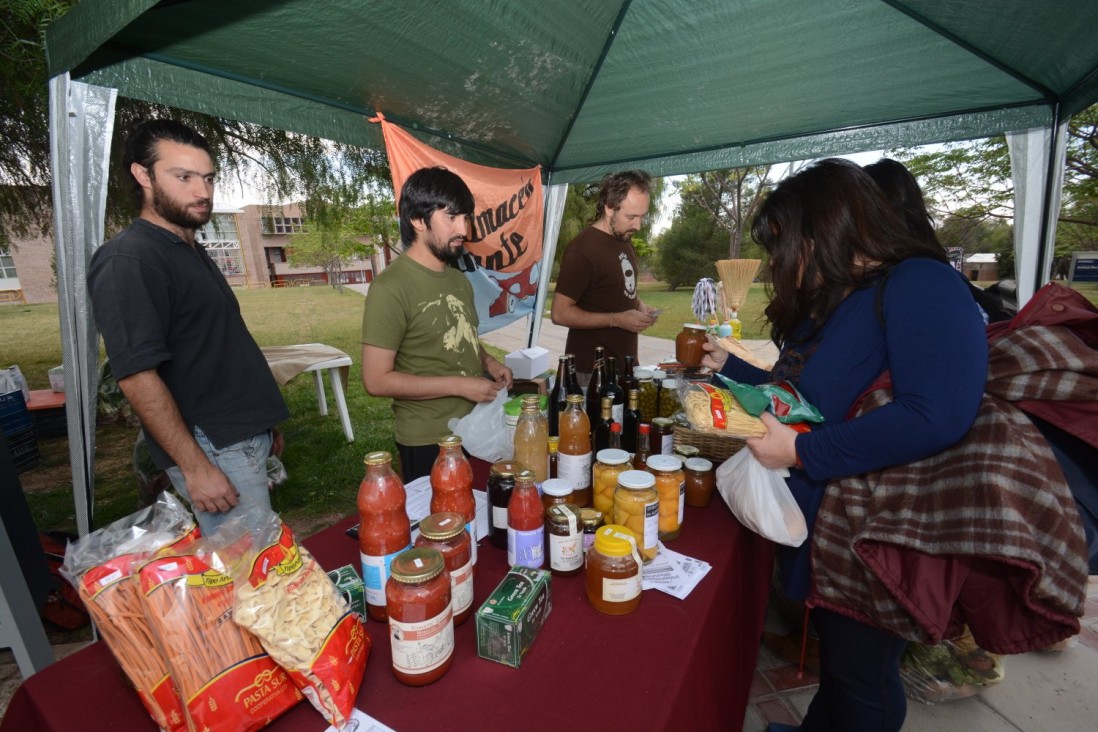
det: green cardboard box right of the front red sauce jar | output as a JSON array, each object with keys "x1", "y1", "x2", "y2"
[{"x1": 477, "y1": 566, "x2": 552, "y2": 668}]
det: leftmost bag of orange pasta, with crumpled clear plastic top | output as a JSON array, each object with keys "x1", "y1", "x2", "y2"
[{"x1": 60, "y1": 493, "x2": 199, "y2": 732}]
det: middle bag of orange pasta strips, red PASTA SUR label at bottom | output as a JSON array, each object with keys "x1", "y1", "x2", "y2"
[{"x1": 139, "y1": 542, "x2": 301, "y2": 732}]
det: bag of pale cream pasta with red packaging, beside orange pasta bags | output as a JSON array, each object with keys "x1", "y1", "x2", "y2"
[{"x1": 225, "y1": 514, "x2": 370, "y2": 729}]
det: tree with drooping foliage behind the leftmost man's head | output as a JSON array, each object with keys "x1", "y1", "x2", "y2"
[{"x1": 0, "y1": 0, "x2": 389, "y2": 245}]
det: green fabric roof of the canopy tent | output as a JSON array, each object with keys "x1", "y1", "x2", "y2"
[{"x1": 46, "y1": 0, "x2": 1098, "y2": 182}]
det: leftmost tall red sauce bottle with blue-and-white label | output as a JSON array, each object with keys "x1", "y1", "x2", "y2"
[{"x1": 358, "y1": 451, "x2": 412, "y2": 621}]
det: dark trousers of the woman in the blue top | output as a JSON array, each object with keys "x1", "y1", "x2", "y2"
[{"x1": 798, "y1": 608, "x2": 907, "y2": 732}]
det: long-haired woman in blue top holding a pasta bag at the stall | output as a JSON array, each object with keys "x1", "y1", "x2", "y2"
[{"x1": 704, "y1": 159, "x2": 987, "y2": 732}]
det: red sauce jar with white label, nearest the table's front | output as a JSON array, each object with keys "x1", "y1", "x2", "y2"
[{"x1": 385, "y1": 547, "x2": 453, "y2": 686}]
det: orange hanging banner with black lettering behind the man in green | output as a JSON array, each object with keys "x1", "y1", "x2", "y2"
[{"x1": 371, "y1": 114, "x2": 545, "y2": 333}]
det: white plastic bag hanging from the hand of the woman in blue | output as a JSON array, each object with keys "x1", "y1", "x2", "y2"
[{"x1": 717, "y1": 448, "x2": 808, "y2": 547}]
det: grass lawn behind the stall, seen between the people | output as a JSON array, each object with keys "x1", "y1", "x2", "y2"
[{"x1": 0, "y1": 277, "x2": 1098, "y2": 536}]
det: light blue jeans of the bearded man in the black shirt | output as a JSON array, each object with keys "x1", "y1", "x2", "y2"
[{"x1": 166, "y1": 427, "x2": 271, "y2": 536}]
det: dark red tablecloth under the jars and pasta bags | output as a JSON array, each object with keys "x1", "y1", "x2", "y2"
[{"x1": 0, "y1": 497, "x2": 772, "y2": 732}]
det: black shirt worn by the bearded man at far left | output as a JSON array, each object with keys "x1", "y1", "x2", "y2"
[{"x1": 88, "y1": 218, "x2": 289, "y2": 468}]
